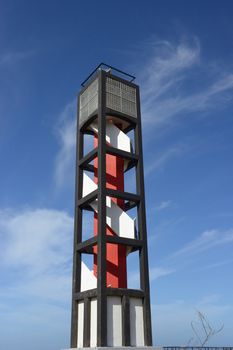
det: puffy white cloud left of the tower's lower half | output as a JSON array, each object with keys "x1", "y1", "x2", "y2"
[{"x1": 0, "y1": 209, "x2": 73, "y2": 273}]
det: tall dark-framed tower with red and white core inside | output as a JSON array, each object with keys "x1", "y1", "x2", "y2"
[{"x1": 71, "y1": 64, "x2": 152, "y2": 348}]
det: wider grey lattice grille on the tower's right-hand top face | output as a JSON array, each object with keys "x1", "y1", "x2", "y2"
[{"x1": 106, "y1": 77, "x2": 137, "y2": 118}]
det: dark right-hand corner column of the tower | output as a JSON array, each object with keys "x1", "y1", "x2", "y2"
[{"x1": 135, "y1": 87, "x2": 152, "y2": 346}]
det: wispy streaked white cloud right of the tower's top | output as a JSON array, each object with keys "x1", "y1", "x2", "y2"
[{"x1": 140, "y1": 38, "x2": 233, "y2": 125}]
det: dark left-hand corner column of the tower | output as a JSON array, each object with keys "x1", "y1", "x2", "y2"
[{"x1": 71, "y1": 95, "x2": 84, "y2": 348}]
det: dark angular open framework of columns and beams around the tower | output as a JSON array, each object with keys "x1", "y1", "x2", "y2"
[{"x1": 71, "y1": 70, "x2": 152, "y2": 348}]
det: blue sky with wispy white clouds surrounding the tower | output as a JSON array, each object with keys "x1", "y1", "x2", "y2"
[{"x1": 0, "y1": 0, "x2": 233, "y2": 350}]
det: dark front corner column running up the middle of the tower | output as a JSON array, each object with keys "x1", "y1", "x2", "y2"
[{"x1": 97, "y1": 70, "x2": 107, "y2": 346}]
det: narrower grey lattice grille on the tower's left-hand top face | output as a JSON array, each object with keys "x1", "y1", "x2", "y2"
[{"x1": 79, "y1": 79, "x2": 98, "y2": 124}]
